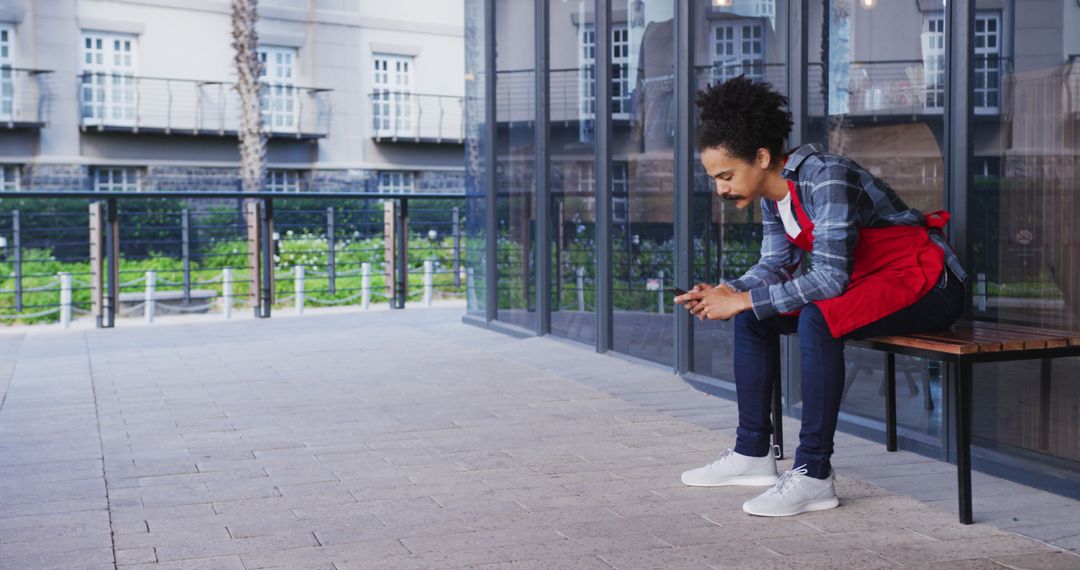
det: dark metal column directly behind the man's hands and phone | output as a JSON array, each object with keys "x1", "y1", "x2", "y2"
[{"x1": 673, "y1": 2, "x2": 695, "y2": 374}]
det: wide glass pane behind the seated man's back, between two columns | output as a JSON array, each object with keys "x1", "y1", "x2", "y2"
[{"x1": 807, "y1": 0, "x2": 947, "y2": 446}]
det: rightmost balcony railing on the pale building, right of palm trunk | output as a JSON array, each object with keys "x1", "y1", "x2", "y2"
[{"x1": 367, "y1": 91, "x2": 465, "y2": 145}]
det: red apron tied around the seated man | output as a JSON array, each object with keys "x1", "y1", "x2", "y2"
[{"x1": 785, "y1": 180, "x2": 949, "y2": 338}]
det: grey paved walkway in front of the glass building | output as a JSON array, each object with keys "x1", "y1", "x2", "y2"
[{"x1": 0, "y1": 310, "x2": 1080, "y2": 570}]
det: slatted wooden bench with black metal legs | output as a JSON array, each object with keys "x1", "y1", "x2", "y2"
[{"x1": 772, "y1": 322, "x2": 1080, "y2": 525}]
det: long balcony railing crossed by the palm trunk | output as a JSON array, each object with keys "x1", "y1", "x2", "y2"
[{"x1": 78, "y1": 72, "x2": 330, "y2": 139}]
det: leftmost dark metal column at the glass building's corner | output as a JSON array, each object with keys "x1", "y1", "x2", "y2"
[{"x1": 484, "y1": 0, "x2": 499, "y2": 322}]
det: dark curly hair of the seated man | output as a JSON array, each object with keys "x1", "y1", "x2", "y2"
[{"x1": 698, "y1": 76, "x2": 792, "y2": 162}]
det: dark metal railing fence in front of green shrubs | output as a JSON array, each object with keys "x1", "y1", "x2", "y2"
[{"x1": 0, "y1": 195, "x2": 471, "y2": 326}]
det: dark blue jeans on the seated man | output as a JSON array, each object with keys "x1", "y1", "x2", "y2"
[{"x1": 734, "y1": 269, "x2": 963, "y2": 478}]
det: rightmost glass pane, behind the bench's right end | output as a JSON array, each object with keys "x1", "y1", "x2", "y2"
[{"x1": 969, "y1": 0, "x2": 1080, "y2": 464}]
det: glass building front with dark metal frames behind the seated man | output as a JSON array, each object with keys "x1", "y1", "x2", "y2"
[{"x1": 464, "y1": 0, "x2": 1080, "y2": 496}]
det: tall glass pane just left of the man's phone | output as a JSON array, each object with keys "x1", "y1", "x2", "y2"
[{"x1": 608, "y1": 0, "x2": 675, "y2": 365}]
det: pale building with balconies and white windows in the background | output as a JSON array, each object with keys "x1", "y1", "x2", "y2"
[{"x1": 0, "y1": 0, "x2": 464, "y2": 193}]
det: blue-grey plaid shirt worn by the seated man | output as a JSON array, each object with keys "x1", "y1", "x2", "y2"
[{"x1": 728, "y1": 145, "x2": 967, "y2": 318}]
